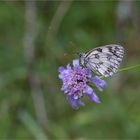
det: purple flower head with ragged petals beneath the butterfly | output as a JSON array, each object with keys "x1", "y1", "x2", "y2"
[{"x1": 58, "y1": 60, "x2": 106, "y2": 109}]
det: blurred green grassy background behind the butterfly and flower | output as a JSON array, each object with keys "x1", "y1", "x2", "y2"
[{"x1": 0, "y1": 0, "x2": 140, "y2": 140}]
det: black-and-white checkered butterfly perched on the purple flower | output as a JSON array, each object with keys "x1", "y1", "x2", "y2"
[{"x1": 79, "y1": 44, "x2": 124, "y2": 77}]
